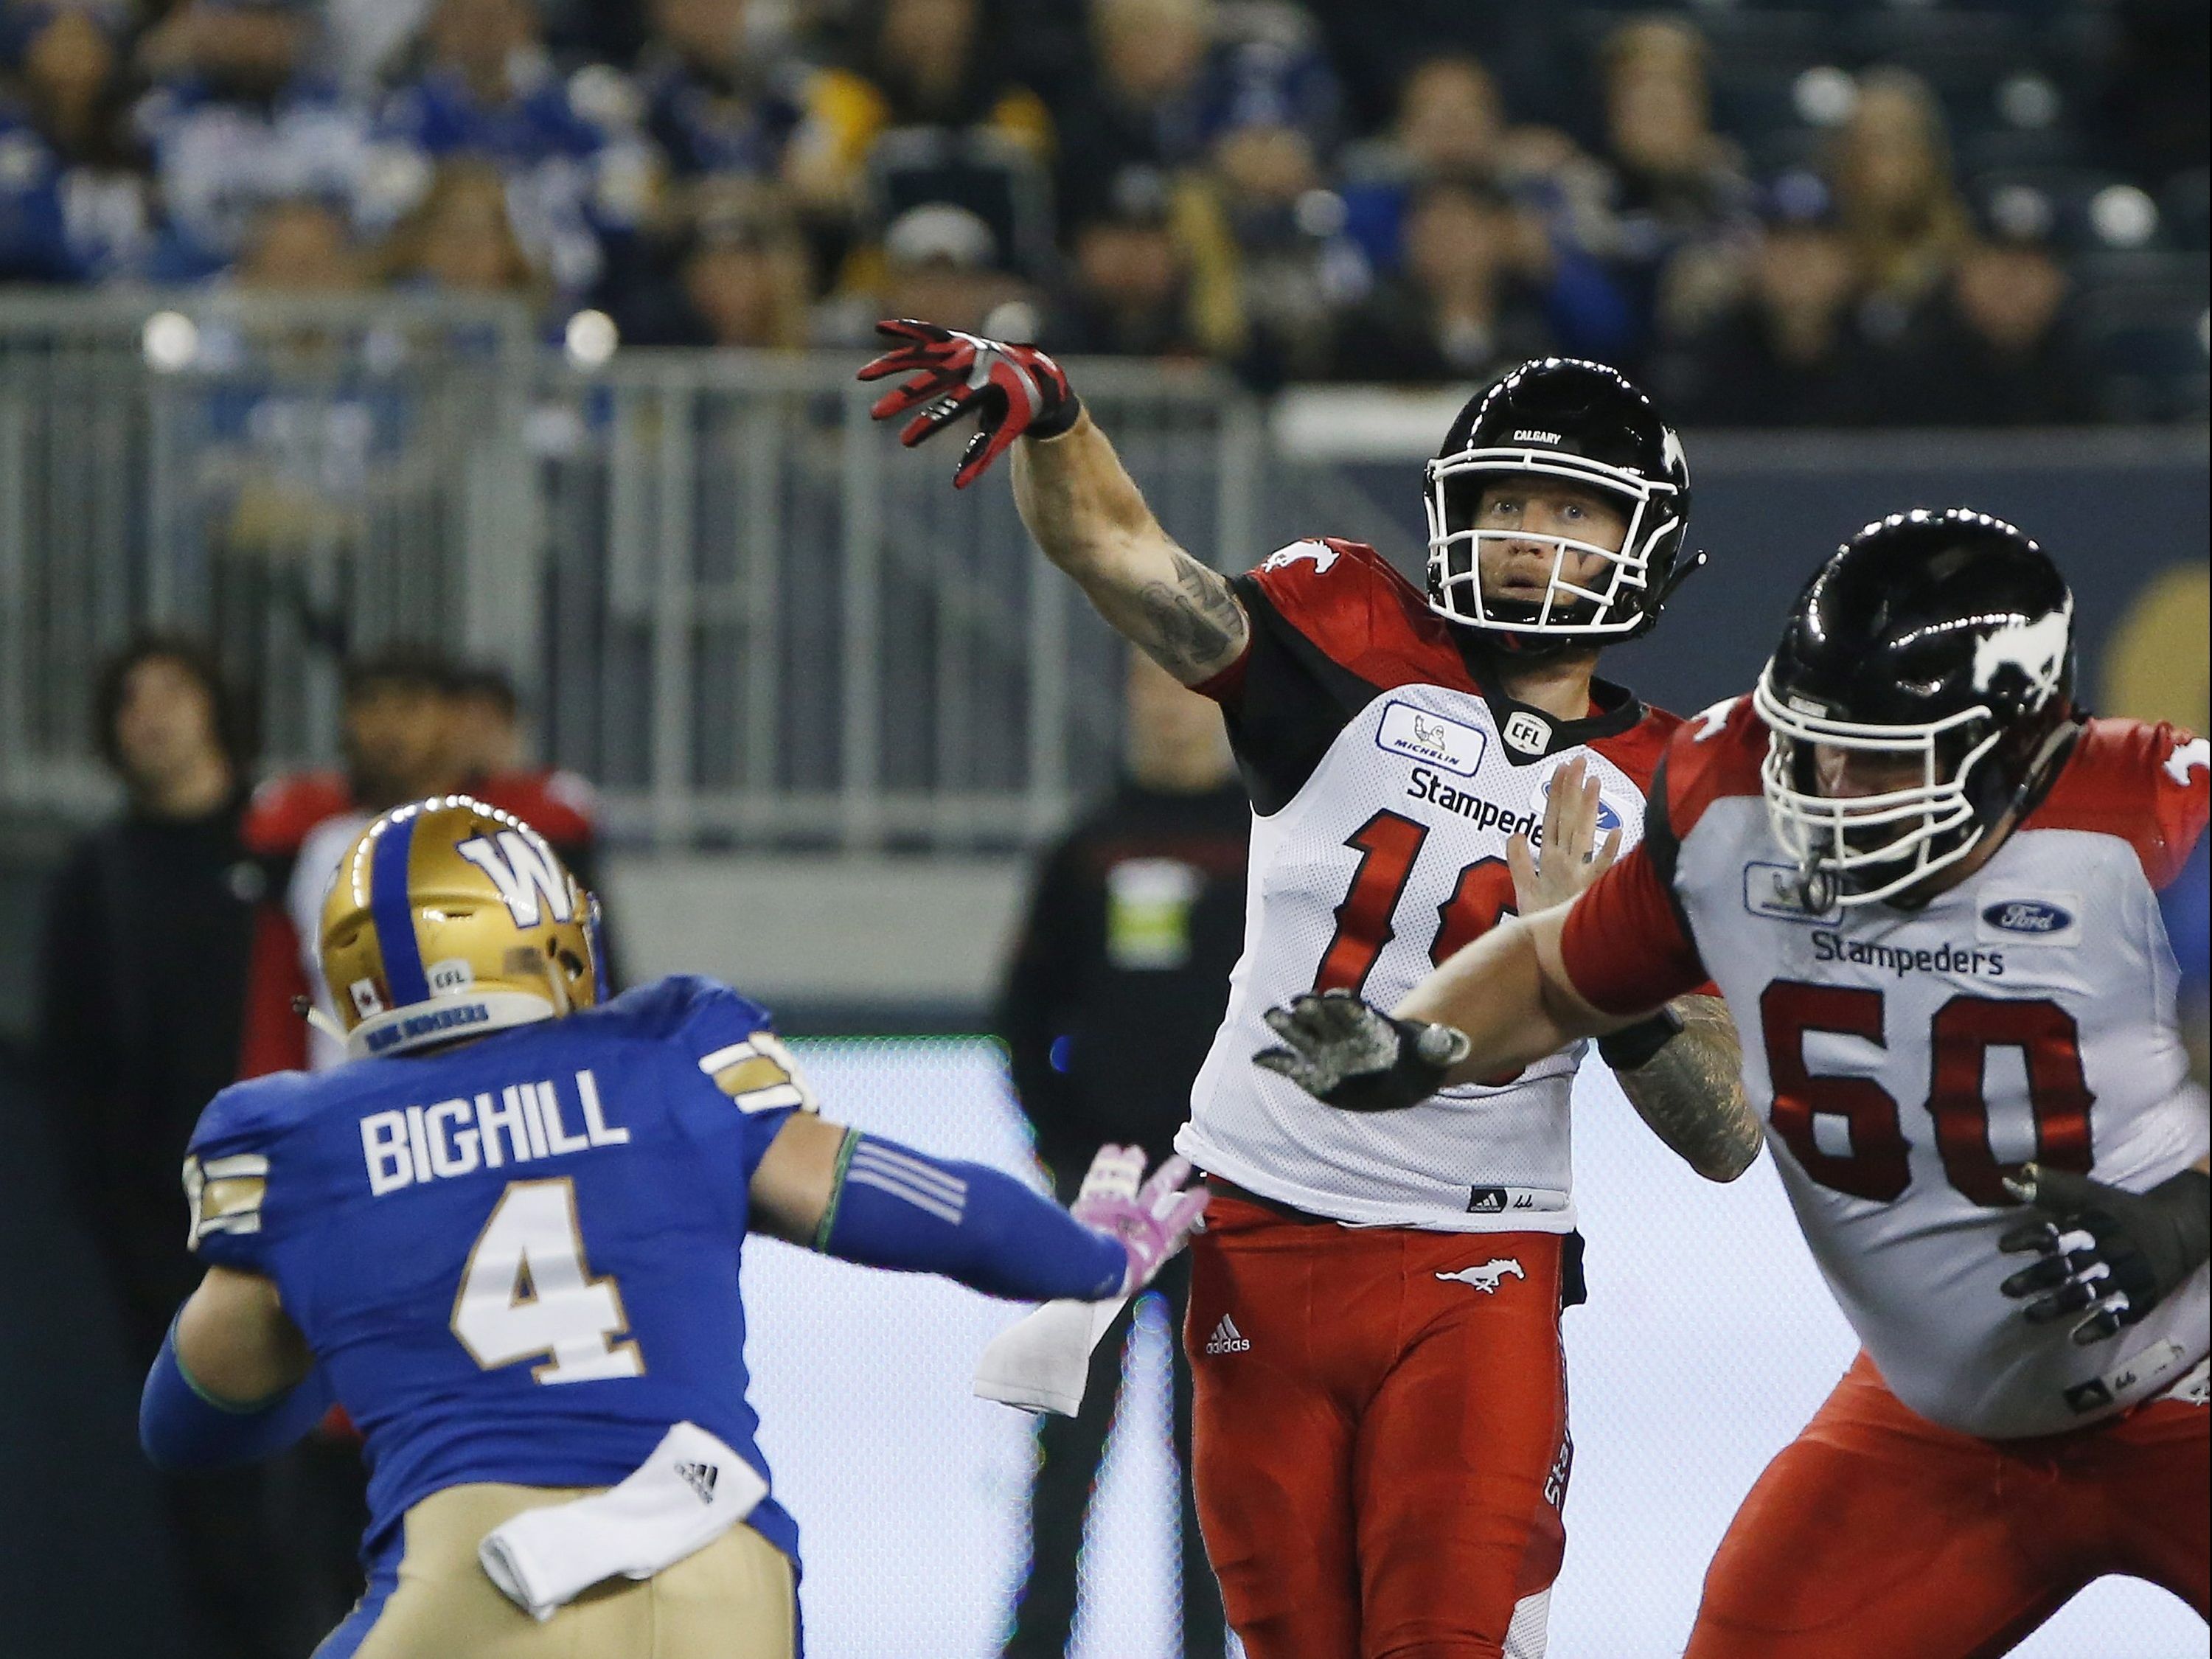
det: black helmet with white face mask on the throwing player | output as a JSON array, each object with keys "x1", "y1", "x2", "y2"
[{"x1": 1427, "y1": 356, "x2": 1703, "y2": 653}]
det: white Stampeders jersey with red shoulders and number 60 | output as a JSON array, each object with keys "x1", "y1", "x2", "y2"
[{"x1": 1568, "y1": 699, "x2": 2212, "y2": 1438}]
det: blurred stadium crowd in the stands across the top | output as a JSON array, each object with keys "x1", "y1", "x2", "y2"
[{"x1": 0, "y1": 0, "x2": 2205, "y2": 427}]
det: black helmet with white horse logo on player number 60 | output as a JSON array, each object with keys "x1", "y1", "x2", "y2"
[{"x1": 1752, "y1": 507, "x2": 2077, "y2": 909}]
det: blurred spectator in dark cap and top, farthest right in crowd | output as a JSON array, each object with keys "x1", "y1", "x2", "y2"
[{"x1": 1882, "y1": 186, "x2": 2093, "y2": 427}]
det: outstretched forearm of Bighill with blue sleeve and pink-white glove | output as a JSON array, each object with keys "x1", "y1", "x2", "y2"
[{"x1": 750, "y1": 1113, "x2": 1206, "y2": 1303}]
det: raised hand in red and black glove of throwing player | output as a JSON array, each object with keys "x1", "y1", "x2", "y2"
[{"x1": 860, "y1": 319, "x2": 1084, "y2": 489}]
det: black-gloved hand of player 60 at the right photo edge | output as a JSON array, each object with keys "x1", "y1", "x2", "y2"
[{"x1": 1997, "y1": 1164, "x2": 2212, "y2": 1347}]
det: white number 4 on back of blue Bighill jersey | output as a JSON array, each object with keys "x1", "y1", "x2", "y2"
[{"x1": 453, "y1": 1177, "x2": 646, "y2": 1382}]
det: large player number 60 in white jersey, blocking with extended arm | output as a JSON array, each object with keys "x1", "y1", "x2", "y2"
[{"x1": 1267, "y1": 509, "x2": 2212, "y2": 1659}]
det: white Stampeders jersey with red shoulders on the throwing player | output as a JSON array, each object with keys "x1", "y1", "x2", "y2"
[{"x1": 1177, "y1": 542, "x2": 1677, "y2": 1232}]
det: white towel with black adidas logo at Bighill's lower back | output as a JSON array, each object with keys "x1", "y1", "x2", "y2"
[{"x1": 476, "y1": 1422, "x2": 768, "y2": 1621}]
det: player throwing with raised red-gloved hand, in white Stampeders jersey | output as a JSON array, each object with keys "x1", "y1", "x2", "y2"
[{"x1": 863, "y1": 323, "x2": 1759, "y2": 1659}]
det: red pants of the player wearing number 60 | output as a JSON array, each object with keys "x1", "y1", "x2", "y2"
[{"x1": 1686, "y1": 1354, "x2": 2212, "y2": 1659}]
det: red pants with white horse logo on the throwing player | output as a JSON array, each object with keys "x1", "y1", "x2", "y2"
[{"x1": 1183, "y1": 1192, "x2": 1573, "y2": 1659}]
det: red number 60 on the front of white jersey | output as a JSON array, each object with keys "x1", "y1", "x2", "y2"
[{"x1": 1759, "y1": 980, "x2": 2095, "y2": 1208}]
